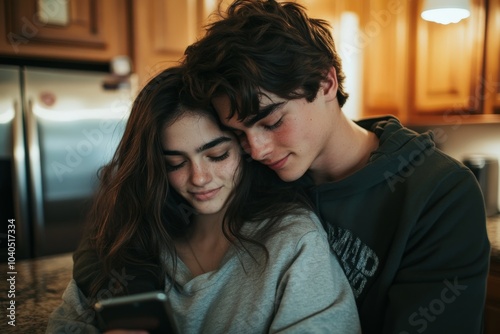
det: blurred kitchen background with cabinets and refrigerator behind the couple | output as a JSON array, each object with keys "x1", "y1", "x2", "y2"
[{"x1": 0, "y1": 0, "x2": 500, "y2": 333}]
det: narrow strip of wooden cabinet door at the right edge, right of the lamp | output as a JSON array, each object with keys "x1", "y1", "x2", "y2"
[{"x1": 483, "y1": 0, "x2": 500, "y2": 117}]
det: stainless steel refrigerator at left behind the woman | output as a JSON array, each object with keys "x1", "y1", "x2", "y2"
[{"x1": 0, "y1": 66, "x2": 132, "y2": 261}]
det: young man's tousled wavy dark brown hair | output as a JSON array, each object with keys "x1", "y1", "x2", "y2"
[{"x1": 184, "y1": 0, "x2": 348, "y2": 120}]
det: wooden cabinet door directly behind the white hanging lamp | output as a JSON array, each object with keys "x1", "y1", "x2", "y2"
[{"x1": 410, "y1": 0, "x2": 485, "y2": 118}]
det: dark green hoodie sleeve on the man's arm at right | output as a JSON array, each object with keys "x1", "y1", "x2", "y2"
[{"x1": 383, "y1": 168, "x2": 490, "y2": 334}]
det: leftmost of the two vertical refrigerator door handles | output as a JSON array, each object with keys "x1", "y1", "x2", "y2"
[{"x1": 12, "y1": 99, "x2": 32, "y2": 258}]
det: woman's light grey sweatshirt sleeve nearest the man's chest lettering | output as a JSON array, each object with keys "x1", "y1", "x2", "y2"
[{"x1": 269, "y1": 215, "x2": 361, "y2": 334}]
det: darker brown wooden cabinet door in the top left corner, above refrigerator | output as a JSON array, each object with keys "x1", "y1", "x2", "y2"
[{"x1": 0, "y1": 0, "x2": 129, "y2": 62}]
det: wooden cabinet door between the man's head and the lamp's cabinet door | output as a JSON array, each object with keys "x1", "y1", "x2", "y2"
[{"x1": 360, "y1": 0, "x2": 410, "y2": 122}]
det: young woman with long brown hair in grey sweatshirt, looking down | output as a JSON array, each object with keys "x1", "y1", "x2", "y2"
[{"x1": 47, "y1": 67, "x2": 360, "y2": 333}]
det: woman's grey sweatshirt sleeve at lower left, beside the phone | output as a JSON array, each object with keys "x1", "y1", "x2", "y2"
[{"x1": 46, "y1": 280, "x2": 100, "y2": 334}]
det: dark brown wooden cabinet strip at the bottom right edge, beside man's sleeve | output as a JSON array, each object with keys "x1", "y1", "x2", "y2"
[{"x1": 484, "y1": 261, "x2": 500, "y2": 334}]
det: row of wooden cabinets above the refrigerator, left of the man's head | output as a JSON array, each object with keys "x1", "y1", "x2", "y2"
[{"x1": 0, "y1": 0, "x2": 225, "y2": 85}]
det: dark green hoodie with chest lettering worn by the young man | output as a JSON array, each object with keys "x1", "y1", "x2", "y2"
[{"x1": 304, "y1": 117, "x2": 490, "y2": 334}]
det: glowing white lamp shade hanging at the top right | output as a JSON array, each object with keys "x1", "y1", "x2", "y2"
[{"x1": 421, "y1": 0, "x2": 470, "y2": 24}]
